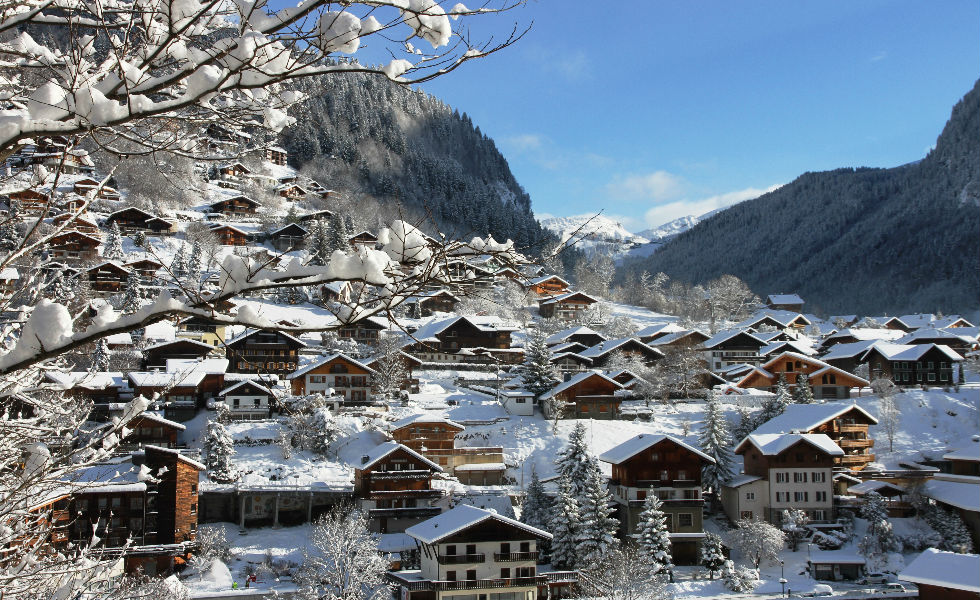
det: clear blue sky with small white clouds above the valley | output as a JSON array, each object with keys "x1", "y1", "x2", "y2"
[{"x1": 422, "y1": 0, "x2": 980, "y2": 231}]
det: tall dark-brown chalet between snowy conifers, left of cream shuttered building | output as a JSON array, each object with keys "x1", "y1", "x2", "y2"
[{"x1": 599, "y1": 434, "x2": 715, "y2": 565}]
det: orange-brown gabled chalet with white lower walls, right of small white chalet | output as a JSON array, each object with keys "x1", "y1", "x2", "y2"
[{"x1": 286, "y1": 354, "x2": 375, "y2": 406}]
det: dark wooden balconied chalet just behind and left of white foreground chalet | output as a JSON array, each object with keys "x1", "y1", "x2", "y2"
[{"x1": 354, "y1": 442, "x2": 442, "y2": 533}]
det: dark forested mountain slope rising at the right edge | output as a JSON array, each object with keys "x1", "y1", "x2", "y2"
[{"x1": 627, "y1": 82, "x2": 980, "y2": 314}]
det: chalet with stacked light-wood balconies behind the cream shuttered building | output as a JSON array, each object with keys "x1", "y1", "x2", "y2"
[{"x1": 752, "y1": 402, "x2": 878, "y2": 471}]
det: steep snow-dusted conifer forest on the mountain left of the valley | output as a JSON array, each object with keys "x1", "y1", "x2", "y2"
[{"x1": 283, "y1": 69, "x2": 557, "y2": 254}]
